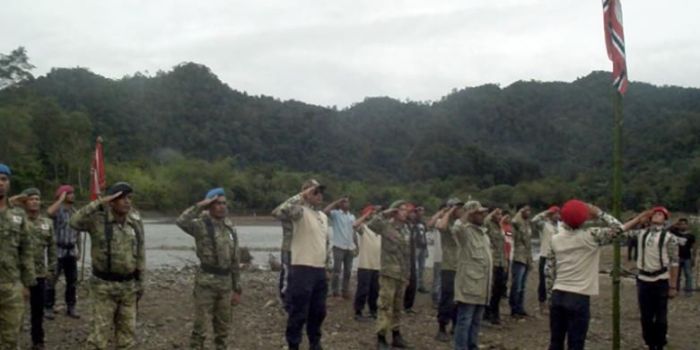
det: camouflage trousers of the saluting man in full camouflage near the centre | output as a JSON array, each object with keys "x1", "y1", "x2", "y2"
[{"x1": 377, "y1": 275, "x2": 406, "y2": 336}]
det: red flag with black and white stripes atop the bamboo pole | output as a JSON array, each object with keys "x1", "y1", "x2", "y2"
[{"x1": 603, "y1": 0, "x2": 629, "y2": 95}]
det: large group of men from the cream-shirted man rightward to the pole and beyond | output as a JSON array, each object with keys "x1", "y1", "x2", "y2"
[{"x1": 273, "y1": 180, "x2": 691, "y2": 350}]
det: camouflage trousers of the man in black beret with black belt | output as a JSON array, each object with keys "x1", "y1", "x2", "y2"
[{"x1": 87, "y1": 277, "x2": 137, "y2": 350}]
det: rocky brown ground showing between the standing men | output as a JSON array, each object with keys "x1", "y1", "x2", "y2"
[{"x1": 23, "y1": 247, "x2": 700, "y2": 350}]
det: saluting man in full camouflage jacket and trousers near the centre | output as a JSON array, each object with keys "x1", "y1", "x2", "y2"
[{"x1": 357, "y1": 200, "x2": 412, "y2": 350}]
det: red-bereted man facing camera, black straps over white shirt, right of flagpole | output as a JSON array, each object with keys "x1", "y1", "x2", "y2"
[{"x1": 627, "y1": 207, "x2": 678, "y2": 350}]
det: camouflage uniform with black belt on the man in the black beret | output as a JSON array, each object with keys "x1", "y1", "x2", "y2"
[{"x1": 70, "y1": 200, "x2": 146, "y2": 349}]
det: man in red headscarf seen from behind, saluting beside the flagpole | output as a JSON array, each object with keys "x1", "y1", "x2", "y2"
[{"x1": 545, "y1": 199, "x2": 639, "y2": 350}]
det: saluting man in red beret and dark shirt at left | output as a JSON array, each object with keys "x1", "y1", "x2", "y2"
[{"x1": 45, "y1": 185, "x2": 80, "y2": 319}]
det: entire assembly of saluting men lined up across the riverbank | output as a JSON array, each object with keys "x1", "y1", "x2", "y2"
[{"x1": 0, "y1": 164, "x2": 691, "y2": 350}]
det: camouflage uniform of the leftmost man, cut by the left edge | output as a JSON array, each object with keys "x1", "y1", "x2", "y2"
[{"x1": 0, "y1": 208, "x2": 36, "y2": 350}]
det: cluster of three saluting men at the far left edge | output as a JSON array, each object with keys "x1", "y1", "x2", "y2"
[{"x1": 0, "y1": 164, "x2": 80, "y2": 349}]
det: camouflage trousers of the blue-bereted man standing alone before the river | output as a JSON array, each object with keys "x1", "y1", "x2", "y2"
[{"x1": 190, "y1": 272, "x2": 232, "y2": 350}]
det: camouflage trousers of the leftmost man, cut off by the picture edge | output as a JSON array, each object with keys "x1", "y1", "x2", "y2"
[{"x1": 0, "y1": 282, "x2": 24, "y2": 350}]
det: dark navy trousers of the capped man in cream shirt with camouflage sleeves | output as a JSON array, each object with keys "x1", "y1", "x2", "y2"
[{"x1": 286, "y1": 265, "x2": 328, "y2": 347}]
